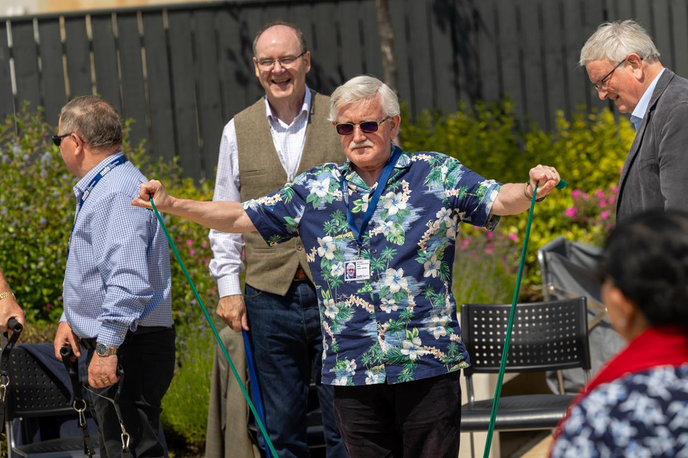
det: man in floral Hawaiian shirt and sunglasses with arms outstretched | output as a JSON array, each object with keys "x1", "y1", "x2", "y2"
[{"x1": 133, "y1": 76, "x2": 559, "y2": 458}]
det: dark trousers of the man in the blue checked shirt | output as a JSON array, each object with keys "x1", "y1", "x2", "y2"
[{"x1": 88, "y1": 328, "x2": 175, "y2": 458}]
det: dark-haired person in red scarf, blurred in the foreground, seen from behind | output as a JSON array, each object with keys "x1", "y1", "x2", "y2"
[{"x1": 551, "y1": 211, "x2": 688, "y2": 458}]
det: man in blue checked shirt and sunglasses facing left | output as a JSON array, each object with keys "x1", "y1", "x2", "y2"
[{"x1": 53, "y1": 96, "x2": 175, "y2": 458}]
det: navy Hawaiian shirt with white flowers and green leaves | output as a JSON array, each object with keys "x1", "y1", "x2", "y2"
[{"x1": 244, "y1": 146, "x2": 501, "y2": 385}]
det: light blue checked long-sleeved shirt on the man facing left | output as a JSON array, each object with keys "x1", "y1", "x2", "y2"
[{"x1": 60, "y1": 153, "x2": 172, "y2": 347}]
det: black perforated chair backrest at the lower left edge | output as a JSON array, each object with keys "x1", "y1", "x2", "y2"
[{"x1": 7, "y1": 346, "x2": 74, "y2": 420}]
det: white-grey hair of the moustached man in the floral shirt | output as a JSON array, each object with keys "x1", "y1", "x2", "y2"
[{"x1": 328, "y1": 75, "x2": 401, "y2": 122}]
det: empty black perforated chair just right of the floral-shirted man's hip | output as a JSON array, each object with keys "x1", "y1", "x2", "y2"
[{"x1": 461, "y1": 297, "x2": 590, "y2": 436}]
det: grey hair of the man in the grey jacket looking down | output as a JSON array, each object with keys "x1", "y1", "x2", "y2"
[{"x1": 579, "y1": 20, "x2": 659, "y2": 67}]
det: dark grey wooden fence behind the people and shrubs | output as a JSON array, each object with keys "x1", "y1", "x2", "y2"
[{"x1": 0, "y1": 0, "x2": 688, "y2": 178}]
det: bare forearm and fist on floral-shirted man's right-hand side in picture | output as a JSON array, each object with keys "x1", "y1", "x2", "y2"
[{"x1": 490, "y1": 165, "x2": 561, "y2": 215}]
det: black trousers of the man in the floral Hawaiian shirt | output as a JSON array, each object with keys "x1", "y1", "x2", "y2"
[{"x1": 334, "y1": 371, "x2": 461, "y2": 458}]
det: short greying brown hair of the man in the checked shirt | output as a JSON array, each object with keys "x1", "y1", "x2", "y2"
[{"x1": 60, "y1": 95, "x2": 122, "y2": 152}]
